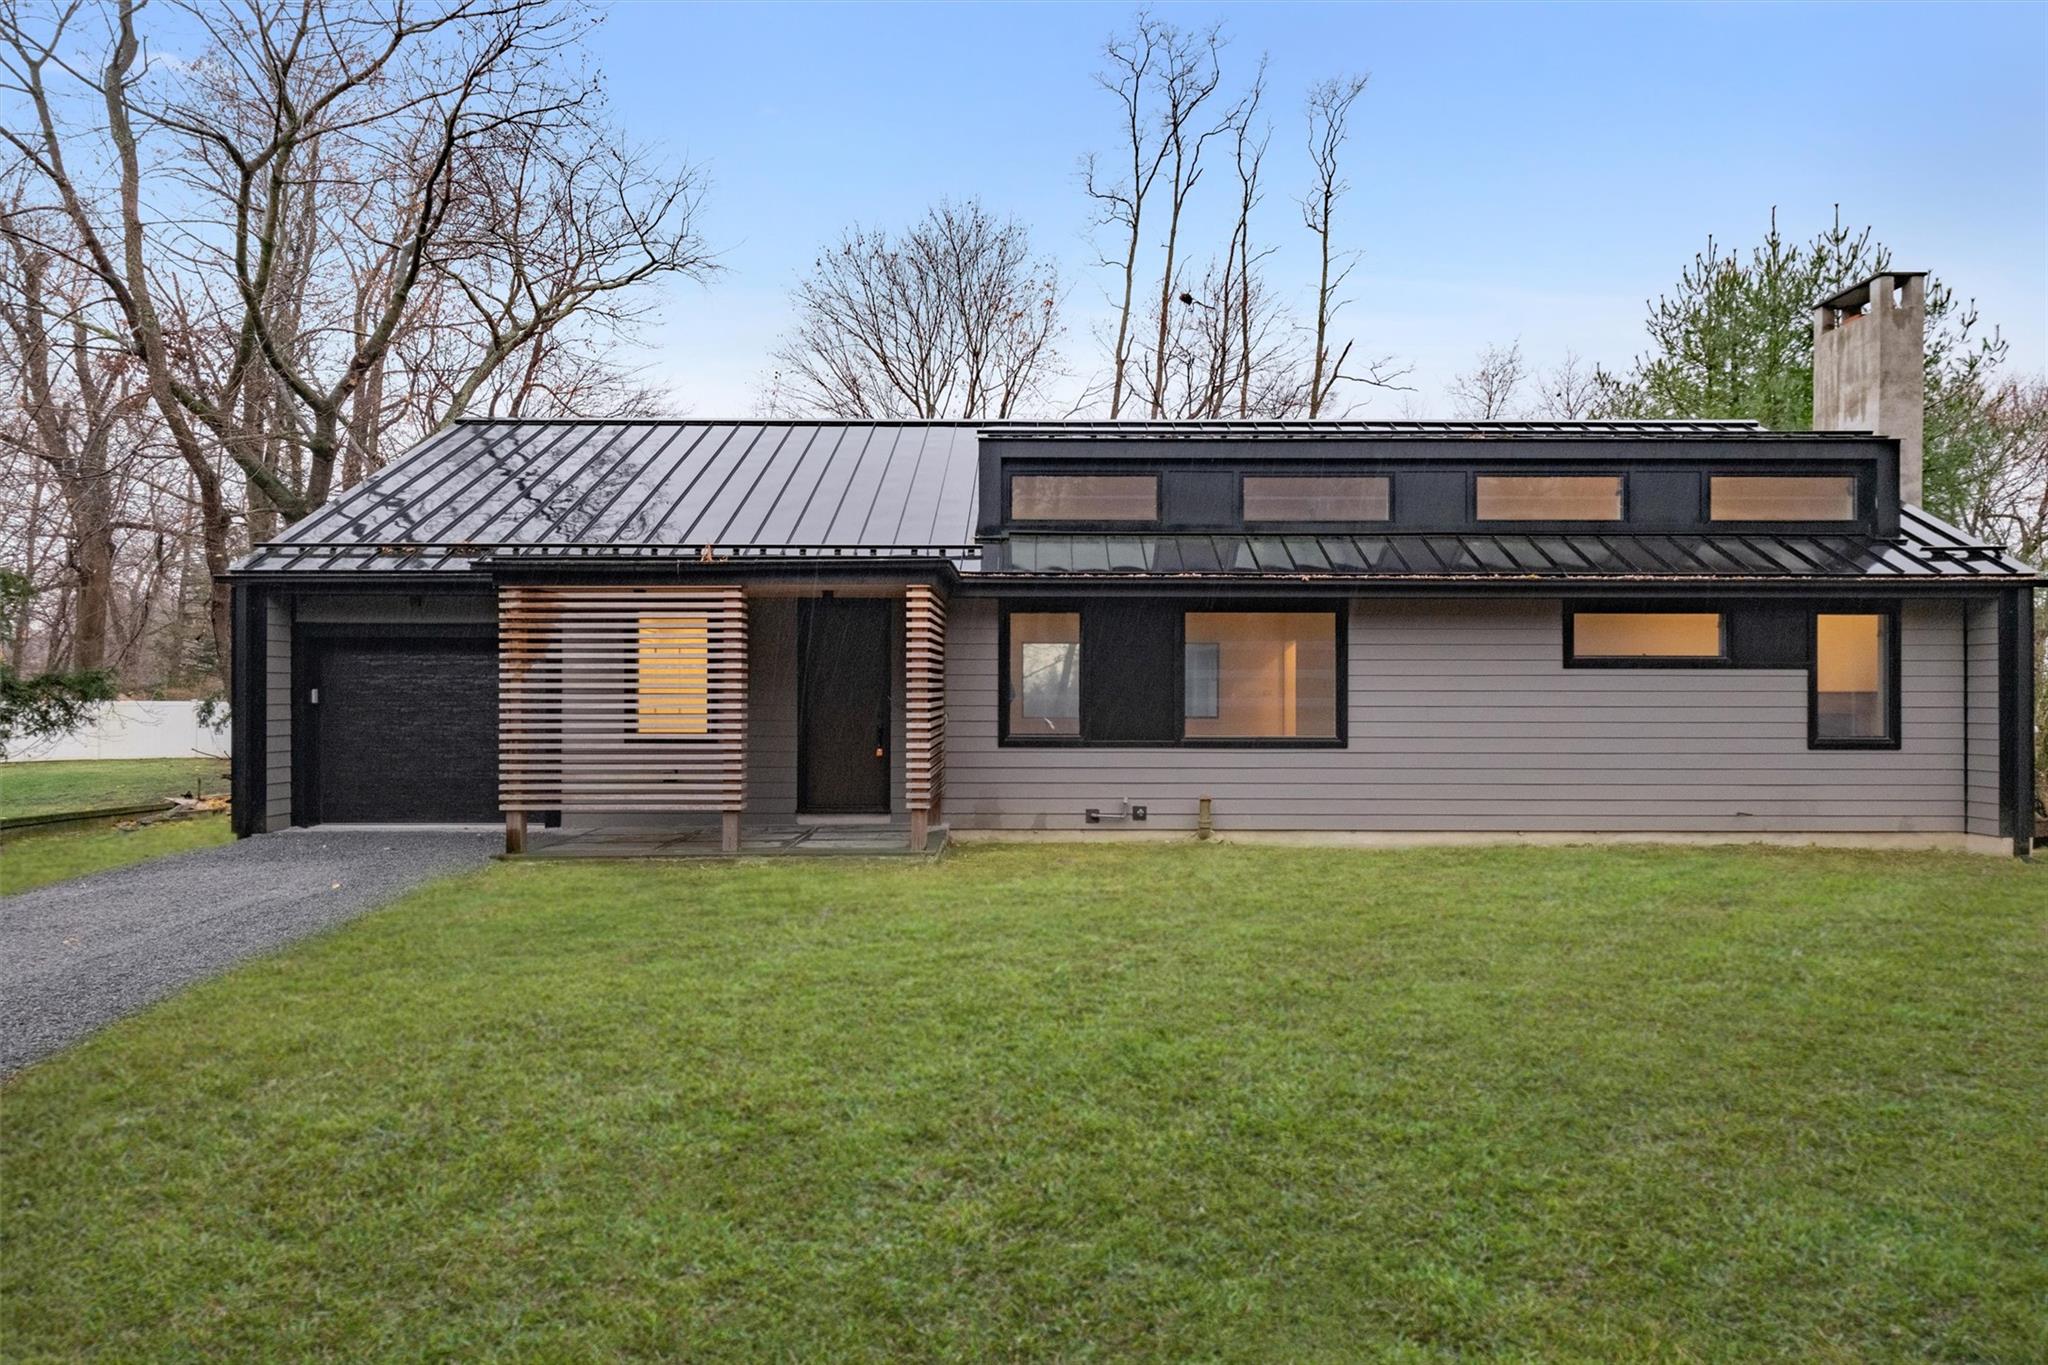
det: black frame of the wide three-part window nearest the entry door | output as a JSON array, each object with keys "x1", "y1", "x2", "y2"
[{"x1": 995, "y1": 598, "x2": 1352, "y2": 749}]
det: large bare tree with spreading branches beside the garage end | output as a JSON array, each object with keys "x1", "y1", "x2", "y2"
[{"x1": 0, "y1": 0, "x2": 709, "y2": 675}]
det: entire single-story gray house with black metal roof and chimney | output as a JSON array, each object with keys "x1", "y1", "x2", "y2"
[{"x1": 233, "y1": 274, "x2": 2044, "y2": 853}]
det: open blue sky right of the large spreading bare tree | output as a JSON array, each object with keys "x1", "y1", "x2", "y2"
[{"x1": 592, "y1": 4, "x2": 2048, "y2": 415}]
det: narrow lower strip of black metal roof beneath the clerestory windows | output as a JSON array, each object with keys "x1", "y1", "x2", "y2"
[{"x1": 981, "y1": 508, "x2": 2036, "y2": 585}]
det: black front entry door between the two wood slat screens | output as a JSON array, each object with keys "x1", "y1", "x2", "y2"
[{"x1": 797, "y1": 598, "x2": 895, "y2": 814}]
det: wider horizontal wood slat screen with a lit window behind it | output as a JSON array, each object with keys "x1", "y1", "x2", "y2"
[{"x1": 498, "y1": 587, "x2": 748, "y2": 810}]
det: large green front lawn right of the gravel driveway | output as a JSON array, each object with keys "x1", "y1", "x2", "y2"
[{"x1": 0, "y1": 845, "x2": 2048, "y2": 1361}]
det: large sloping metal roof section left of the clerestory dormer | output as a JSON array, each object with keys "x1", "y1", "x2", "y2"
[{"x1": 238, "y1": 420, "x2": 981, "y2": 573}]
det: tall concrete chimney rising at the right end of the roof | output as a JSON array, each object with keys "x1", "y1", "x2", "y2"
[{"x1": 1812, "y1": 270, "x2": 1927, "y2": 505}]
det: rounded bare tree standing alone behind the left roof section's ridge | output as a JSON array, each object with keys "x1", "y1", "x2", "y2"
[{"x1": 764, "y1": 201, "x2": 1061, "y2": 417}]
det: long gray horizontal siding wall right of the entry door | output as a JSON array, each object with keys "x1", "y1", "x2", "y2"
[{"x1": 946, "y1": 600, "x2": 1964, "y2": 833}]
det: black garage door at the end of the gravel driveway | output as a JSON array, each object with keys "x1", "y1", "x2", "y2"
[{"x1": 293, "y1": 636, "x2": 498, "y2": 825}]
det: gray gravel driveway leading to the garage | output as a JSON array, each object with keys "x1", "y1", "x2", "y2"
[{"x1": 0, "y1": 829, "x2": 502, "y2": 1074}]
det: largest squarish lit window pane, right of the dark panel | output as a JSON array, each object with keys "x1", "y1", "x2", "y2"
[{"x1": 1182, "y1": 612, "x2": 1337, "y2": 739}]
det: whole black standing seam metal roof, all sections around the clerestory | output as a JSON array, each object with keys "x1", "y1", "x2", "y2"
[{"x1": 236, "y1": 420, "x2": 2032, "y2": 581}]
